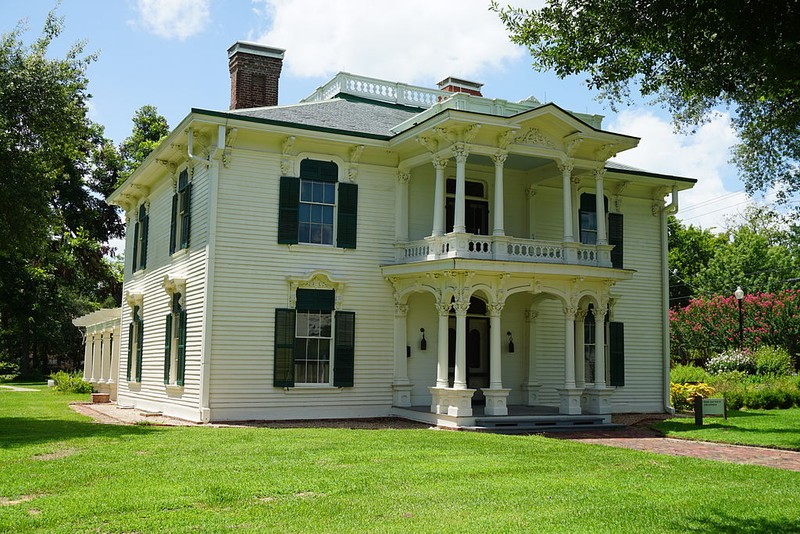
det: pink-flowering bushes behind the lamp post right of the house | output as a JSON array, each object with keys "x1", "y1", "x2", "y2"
[{"x1": 669, "y1": 289, "x2": 800, "y2": 360}]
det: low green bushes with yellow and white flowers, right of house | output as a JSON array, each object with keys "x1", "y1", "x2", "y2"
[{"x1": 670, "y1": 346, "x2": 800, "y2": 410}]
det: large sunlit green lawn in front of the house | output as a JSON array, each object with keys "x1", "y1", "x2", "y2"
[{"x1": 0, "y1": 390, "x2": 800, "y2": 533}]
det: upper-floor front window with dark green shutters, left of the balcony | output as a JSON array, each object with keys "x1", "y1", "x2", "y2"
[{"x1": 278, "y1": 159, "x2": 358, "y2": 248}]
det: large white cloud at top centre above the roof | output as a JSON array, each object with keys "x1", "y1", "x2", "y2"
[{"x1": 255, "y1": 0, "x2": 542, "y2": 84}]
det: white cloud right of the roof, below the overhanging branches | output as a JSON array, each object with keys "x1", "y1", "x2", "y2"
[{"x1": 608, "y1": 109, "x2": 750, "y2": 230}]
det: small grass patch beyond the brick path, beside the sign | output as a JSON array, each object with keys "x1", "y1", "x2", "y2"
[{"x1": 654, "y1": 408, "x2": 800, "y2": 451}]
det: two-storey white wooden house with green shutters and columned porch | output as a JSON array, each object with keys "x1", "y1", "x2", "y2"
[{"x1": 100, "y1": 42, "x2": 695, "y2": 425}]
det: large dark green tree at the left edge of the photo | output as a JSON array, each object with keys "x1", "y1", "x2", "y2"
[{"x1": 0, "y1": 12, "x2": 124, "y2": 382}]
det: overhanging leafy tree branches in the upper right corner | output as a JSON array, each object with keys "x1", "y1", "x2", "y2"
[{"x1": 492, "y1": 0, "x2": 800, "y2": 199}]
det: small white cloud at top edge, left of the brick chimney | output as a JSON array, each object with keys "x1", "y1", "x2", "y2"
[{"x1": 131, "y1": 0, "x2": 211, "y2": 41}]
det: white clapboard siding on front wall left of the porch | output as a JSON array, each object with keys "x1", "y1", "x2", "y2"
[{"x1": 205, "y1": 151, "x2": 396, "y2": 418}]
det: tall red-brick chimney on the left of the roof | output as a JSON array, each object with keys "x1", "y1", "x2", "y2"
[{"x1": 228, "y1": 41, "x2": 285, "y2": 109}]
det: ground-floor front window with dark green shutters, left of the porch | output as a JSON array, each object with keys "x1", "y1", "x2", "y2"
[{"x1": 274, "y1": 289, "x2": 355, "y2": 387}]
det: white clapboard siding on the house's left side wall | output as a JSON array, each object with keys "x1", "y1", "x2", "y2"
[{"x1": 118, "y1": 166, "x2": 209, "y2": 420}]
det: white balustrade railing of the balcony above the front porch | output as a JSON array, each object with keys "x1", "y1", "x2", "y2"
[{"x1": 396, "y1": 234, "x2": 613, "y2": 267}]
